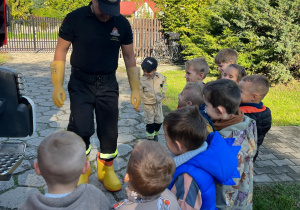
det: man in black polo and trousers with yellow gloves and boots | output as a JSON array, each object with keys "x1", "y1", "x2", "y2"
[{"x1": 50, "y1": 0, "x2": 141, "y2": 191}]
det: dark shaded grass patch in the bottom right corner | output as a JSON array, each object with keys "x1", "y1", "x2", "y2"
[{"x1": 253, "y1": 183, "x2": 300, "y2": 210}]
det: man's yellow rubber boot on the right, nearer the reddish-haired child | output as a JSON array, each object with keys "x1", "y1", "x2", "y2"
[{"x1": 97, "y1": 152, "x2": 122, "y2": 192}]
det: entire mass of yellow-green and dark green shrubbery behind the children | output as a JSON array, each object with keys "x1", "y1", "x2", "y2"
[{"x1": 155, "y1": 0, "x2": 300, "y2": 82}]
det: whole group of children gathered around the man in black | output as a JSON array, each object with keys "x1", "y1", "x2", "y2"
[{"x1": 20, "y1": 49, "x2": 271, "y2": 210}]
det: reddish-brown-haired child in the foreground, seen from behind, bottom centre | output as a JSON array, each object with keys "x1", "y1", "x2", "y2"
[{"x1": 114, "y1": 141, "x2": 180, "y2": 210}]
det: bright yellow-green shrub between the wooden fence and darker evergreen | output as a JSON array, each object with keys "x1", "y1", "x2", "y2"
[{"x1": 155, "y1": 0, "x2": 227, "y2": 73}]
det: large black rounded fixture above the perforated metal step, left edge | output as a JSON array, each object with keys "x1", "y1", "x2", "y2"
[{"x1": 0, "y1": 67, "x2": 35, "y2": 137}]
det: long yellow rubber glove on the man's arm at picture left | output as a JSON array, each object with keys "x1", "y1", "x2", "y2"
[{"x1": 50, "y1": 61, "x2": 66, "y2": 107}]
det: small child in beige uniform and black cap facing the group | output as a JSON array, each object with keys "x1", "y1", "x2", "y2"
[{"x1": 137, "y1": 57, "x2": 168, "y2": 141}]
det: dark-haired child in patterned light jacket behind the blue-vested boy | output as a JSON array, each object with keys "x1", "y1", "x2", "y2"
[{"x1": 203, "y1": 79, "x2": 257, "y2": 209}]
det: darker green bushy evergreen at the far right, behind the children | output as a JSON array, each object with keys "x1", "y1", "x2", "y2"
[{"x1": 213, "y1": 0, "x2": 300, "y2": 82}]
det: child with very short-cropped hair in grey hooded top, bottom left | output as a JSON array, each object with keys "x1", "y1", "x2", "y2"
[{"x1": 19, "y1": 131, "x2": 110, "y2": 210}]
